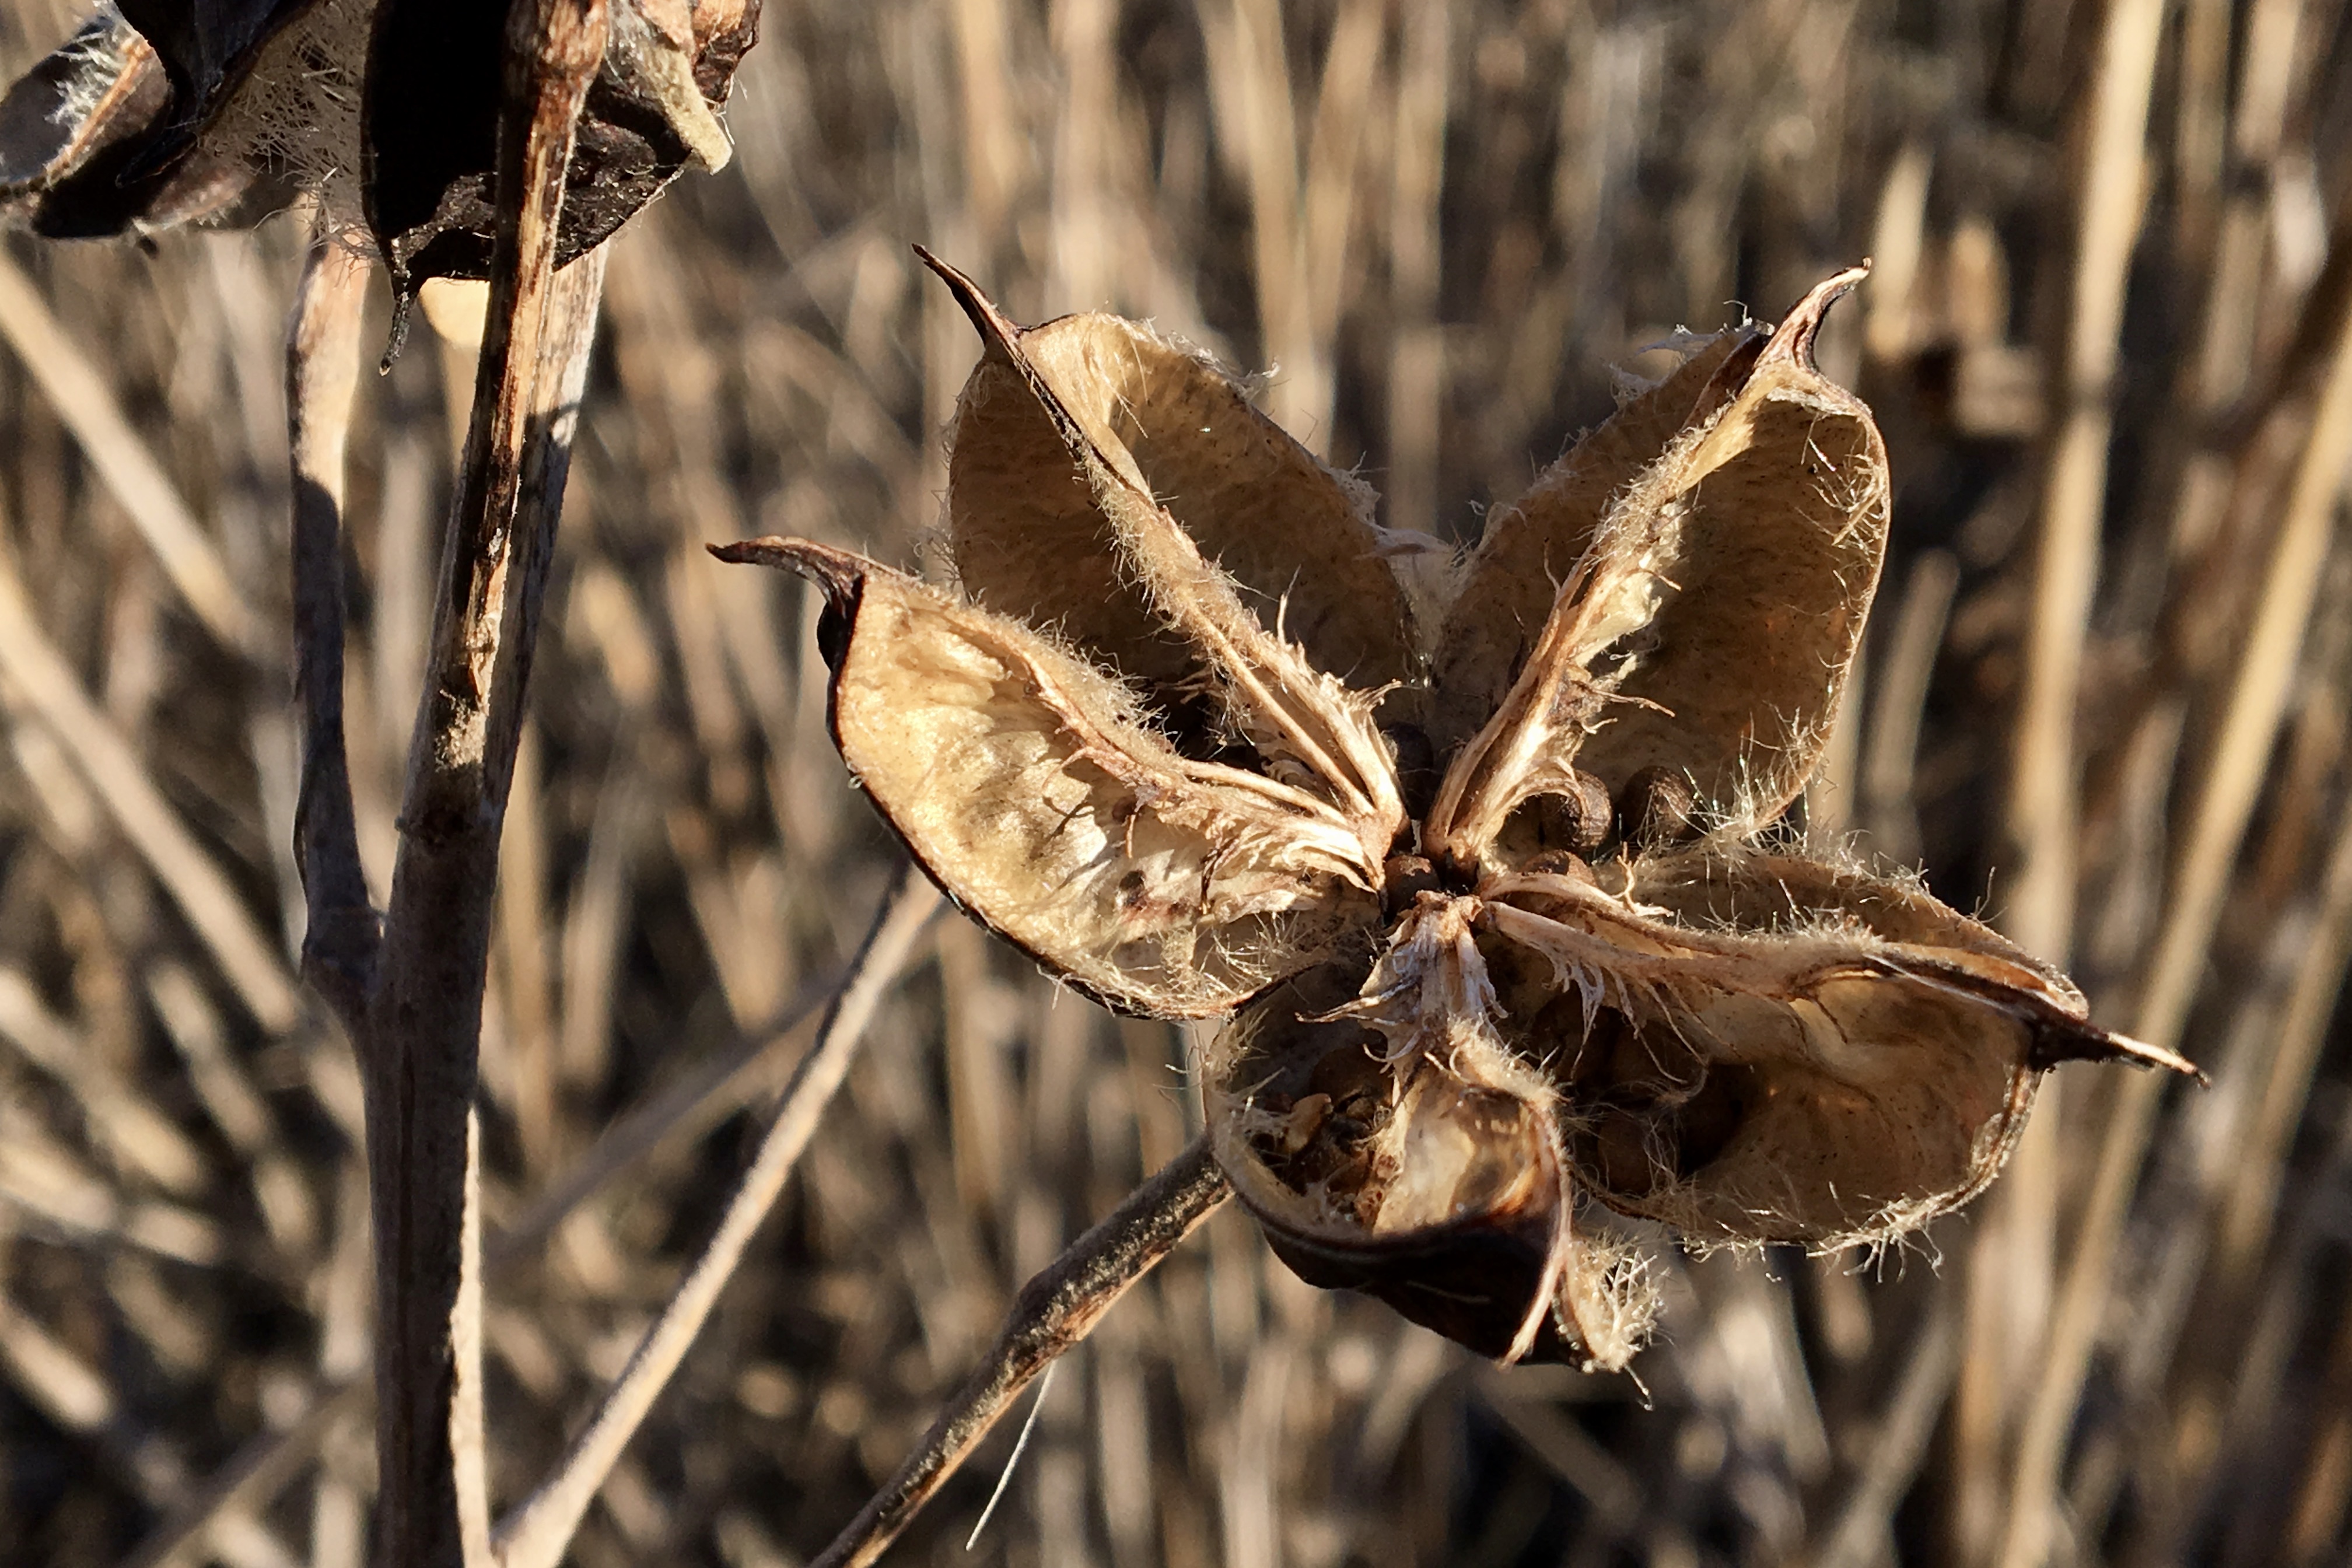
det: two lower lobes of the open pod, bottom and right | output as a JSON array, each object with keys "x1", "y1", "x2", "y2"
[{"x1": 1206, "y1": 851, "x2": 2190, "y2": 1366}]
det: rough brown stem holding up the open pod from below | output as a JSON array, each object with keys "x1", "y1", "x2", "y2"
[{"x1": 814, "y1": 1133, "x2": 1233, "y2": 1568}]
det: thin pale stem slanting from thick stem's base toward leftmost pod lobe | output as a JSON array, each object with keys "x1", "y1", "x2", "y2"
[{"x1": 496, "y1": 865, "x2": 941, "y2": 1568}]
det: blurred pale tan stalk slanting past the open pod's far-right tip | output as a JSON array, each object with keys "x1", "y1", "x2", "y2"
[{"x1": 1999, "y1": 217, "x2": 2352, "y2": 1568}]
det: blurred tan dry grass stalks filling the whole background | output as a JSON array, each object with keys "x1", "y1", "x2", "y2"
[{"x1": 0, "y1": 0, "x2": 2352, "y2": 1568}]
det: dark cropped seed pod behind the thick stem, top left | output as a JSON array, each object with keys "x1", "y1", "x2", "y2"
[{"x1": 0, "y1": 0, "x2": 760, "y2": 292}]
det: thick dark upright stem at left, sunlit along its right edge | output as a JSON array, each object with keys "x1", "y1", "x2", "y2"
[{"x1": 358, "y1": 0, "x2": 607, "y2": 1568}]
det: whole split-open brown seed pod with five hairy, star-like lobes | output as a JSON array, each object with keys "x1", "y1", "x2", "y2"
[{"x1": 715, "y1": 254, "x2": 2194, "y2": 1368}]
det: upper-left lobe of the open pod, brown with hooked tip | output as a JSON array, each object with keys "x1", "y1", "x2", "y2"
[{"x1": 932, "y1": 261, "x2": 1413, "y2": 738}]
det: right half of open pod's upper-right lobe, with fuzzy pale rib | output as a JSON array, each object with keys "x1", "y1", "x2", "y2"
[{"x1": 1425, "y1": 270, "x2": 1889, "y2": 865}]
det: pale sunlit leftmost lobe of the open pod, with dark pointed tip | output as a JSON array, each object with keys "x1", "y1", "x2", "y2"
[{"x1": 720, "y1": 541, "x2": 1381, "y2": 1018}]
